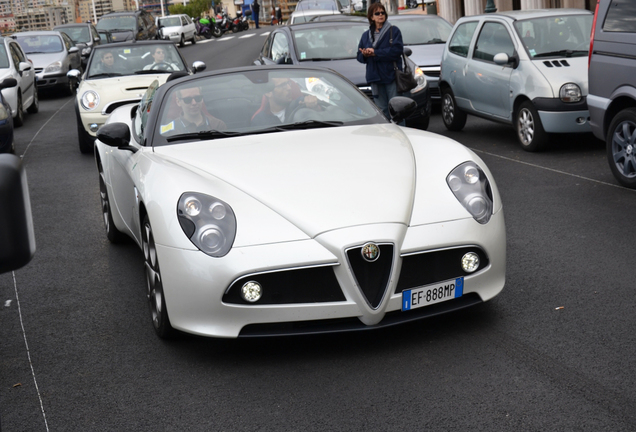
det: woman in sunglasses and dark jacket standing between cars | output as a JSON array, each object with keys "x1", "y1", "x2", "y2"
[{"x1": 358, "y1": 2, "x2": 404, "y2": 118}]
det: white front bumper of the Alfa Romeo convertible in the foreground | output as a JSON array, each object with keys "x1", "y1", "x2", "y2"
[{"x1": 156, "y1": 211, "x2": 506, "y2": 338}]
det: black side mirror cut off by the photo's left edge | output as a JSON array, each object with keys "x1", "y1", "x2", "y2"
[{"x1": 0, "y1": 154, "x2": 35, "y2": 273}]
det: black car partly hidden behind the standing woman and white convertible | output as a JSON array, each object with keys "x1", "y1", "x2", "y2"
[{"x1": 254, "y1": 19, "x2": 431, "y2": 129}]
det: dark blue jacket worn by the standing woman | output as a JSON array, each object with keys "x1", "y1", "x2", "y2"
[{"x1": 358, "y1": 23, "x2": 404, "y2": 84}]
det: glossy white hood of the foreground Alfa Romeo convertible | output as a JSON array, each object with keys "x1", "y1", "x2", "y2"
[{"x1": 154, "y1": 124, "x2": 416, "y2": 237}]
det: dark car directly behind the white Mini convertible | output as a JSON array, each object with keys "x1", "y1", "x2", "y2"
[{"x1": 95, "y1": 10, "x2": 157, "y2": 42}]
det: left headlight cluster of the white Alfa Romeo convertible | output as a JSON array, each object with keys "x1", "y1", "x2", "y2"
[{"x1": 177, "y1": 192, "x2": 236, "y2": 257}]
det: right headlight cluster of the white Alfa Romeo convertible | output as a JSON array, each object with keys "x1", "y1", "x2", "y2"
[{"x1": 446, "y1": 162, "x2": 493, "y2": 224}]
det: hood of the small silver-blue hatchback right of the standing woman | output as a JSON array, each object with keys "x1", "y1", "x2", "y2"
[{"x1": 532, "y1": 56, "x2": 588, "y2": 97}]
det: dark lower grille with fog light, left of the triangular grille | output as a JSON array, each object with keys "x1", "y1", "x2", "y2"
[{"x1": 223, "y1": 266, "x2": 346, "y2": 306}]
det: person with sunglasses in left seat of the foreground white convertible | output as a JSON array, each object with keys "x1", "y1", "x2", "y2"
[{"x1": 161, "y1": 87, "x2": 227, "y2": 135}]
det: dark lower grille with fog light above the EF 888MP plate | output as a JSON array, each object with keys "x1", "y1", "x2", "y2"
[{"x1": 395, "y1": 246, "x2": 489, "y2": 294}]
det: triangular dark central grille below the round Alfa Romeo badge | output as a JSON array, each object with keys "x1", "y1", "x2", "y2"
[{"x1": 347, "y1": 244, "x2": 393, "y2": 309}]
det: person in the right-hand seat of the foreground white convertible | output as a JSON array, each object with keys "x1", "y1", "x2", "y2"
[{"x1": 252, "y1": 78, "x2": 321, "y2": 126}]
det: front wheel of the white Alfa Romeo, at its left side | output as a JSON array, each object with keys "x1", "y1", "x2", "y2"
[{"x1": 141, "y1": 216, "x2": 175, "y2": 339}]
